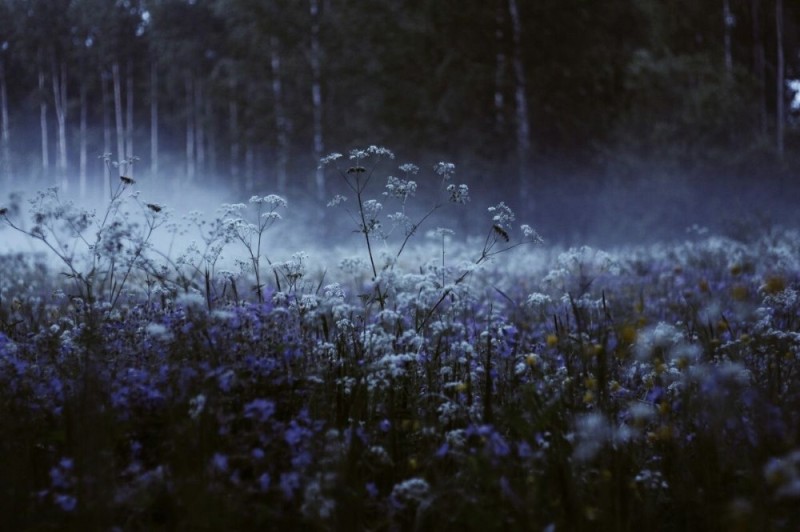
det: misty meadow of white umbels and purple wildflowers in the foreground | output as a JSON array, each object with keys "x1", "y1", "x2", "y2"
[{"x1": 0, "y1": 147, "x2": 800, "y2": 531}]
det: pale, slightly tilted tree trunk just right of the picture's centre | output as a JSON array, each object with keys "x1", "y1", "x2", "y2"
[{"x1": 508, "y1": 0, "x2": 531, "y2": 201}]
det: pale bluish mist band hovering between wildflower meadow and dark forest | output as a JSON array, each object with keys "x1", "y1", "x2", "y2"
[{"x1": 0, "y1": 161, "x2": 800, "y2": 270}]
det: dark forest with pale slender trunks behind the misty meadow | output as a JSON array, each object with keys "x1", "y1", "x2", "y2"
[{"x1": 0, "y1": 0, "x2": 800, "y2": 209}]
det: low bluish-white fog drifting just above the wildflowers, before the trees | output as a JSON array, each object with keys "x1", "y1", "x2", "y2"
[{"x1": 0, "y1": 168, "x2": 800, "y2": 282}]
